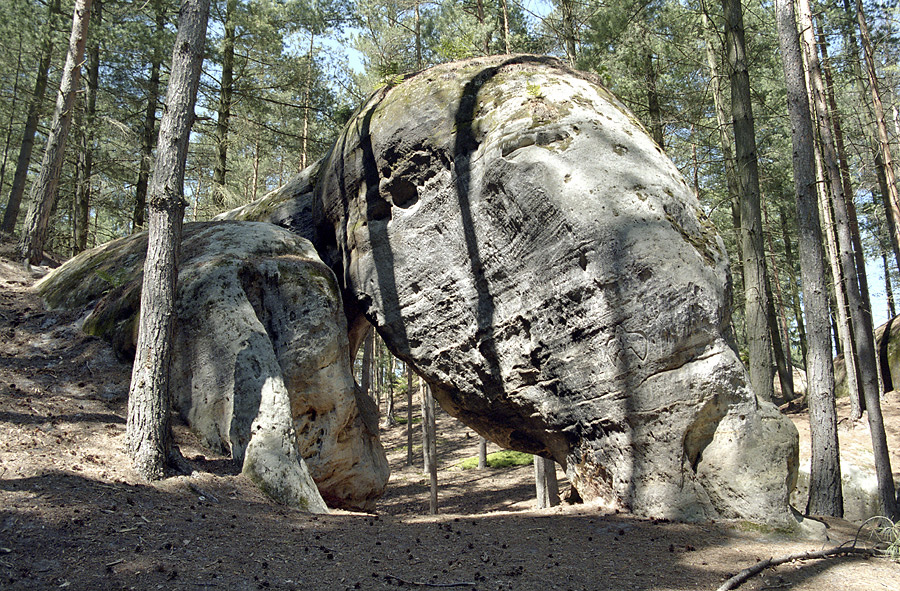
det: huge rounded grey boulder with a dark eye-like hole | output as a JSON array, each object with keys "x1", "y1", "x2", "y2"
[{"x1": 307, "y1": 56, "x2": 797, "y2": 523}]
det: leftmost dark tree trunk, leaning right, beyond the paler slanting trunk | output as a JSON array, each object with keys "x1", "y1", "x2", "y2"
[{"x1": 0, "y1": 0, "x2": 60, "y2": 234}]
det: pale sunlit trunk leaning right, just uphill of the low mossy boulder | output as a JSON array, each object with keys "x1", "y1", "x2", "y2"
[{"x1": 19, "y1": 0, "x2": 91, "y2": 265}]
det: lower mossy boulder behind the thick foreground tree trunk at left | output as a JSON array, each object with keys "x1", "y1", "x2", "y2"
[{"x1": 38, "y1": 222, "x2": 388, "y2": 511}]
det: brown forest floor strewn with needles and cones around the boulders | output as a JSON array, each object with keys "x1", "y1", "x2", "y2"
[{"x1": 0, "y1": 238, "x2": 900, "y2": 591}]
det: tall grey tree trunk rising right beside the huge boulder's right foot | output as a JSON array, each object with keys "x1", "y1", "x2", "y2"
[{"x1": 775, "y1": 0, "x2": 844, "y2": 517}]
